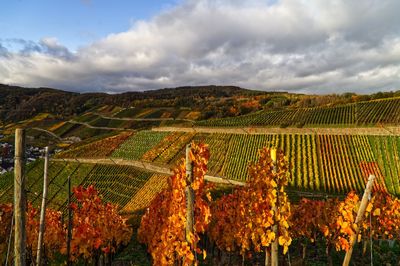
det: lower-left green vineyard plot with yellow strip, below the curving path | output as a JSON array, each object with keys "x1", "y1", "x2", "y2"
[{"x1": 0, "y1": 160, "x2": 167, "y2": 213}]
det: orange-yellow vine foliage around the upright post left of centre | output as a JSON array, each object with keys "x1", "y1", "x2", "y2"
[{"x1": 138, "y1": 143, "x2": 211, "y2": 265}]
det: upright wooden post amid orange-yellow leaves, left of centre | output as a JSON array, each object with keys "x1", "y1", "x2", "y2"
[{"x1": 185, "y1": 144, "x2": 196, "y2": 264}]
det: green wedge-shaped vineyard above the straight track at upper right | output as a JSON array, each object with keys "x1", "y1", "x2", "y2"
[{"x1": 196, "y1": 98, "x2": 400, "y2": 127}]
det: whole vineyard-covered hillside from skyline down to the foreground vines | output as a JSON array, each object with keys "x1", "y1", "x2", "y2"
[{"x1": 0, "y1": 86, "x2": 400, "y2": 260}]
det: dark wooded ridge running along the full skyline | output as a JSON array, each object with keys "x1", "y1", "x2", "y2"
[{"x1": 0, "y1": 84, "x2": 400, "y2": 126}]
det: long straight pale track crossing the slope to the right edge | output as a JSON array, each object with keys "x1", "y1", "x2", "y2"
[{"x1": 152, "y1": 126, "x2": 400, "y2": 136}]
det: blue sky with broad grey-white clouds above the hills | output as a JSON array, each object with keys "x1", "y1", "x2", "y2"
[{"x1": 0, "y1": 0, "x2": 400, "y2": 94}]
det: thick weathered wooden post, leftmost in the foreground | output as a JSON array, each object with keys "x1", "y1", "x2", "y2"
[{"x1": 14, "y1": 128, "x2": 26, "y2": 266}]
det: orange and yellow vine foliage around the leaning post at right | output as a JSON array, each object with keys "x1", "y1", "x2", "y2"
[{"x1": 290, "y1": 191, "x2": 400, "y2": 264}]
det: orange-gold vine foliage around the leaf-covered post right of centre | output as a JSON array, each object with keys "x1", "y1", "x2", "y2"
[{"x1": 209, "y1": 148, "x2": 292, "y2": 255}]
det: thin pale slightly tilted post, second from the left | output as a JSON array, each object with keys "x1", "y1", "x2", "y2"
[{"x1": 36, "y1": 147, "x2": 49, "y2": 266}]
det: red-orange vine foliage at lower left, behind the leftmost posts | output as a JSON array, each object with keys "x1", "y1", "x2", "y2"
[{"x1": 0, "y1": 186, "x2": 132, "y2": 262}]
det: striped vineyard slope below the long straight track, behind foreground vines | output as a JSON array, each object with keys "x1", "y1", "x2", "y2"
[{"x1": 0, "y1": 131, "x2": 400, "y2": 212}]
